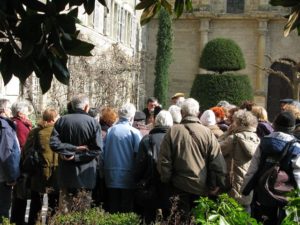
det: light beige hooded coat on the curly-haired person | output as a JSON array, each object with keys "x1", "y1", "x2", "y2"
[{"x1": 220, "y1": 127, "x2": 260, "y2": 205}]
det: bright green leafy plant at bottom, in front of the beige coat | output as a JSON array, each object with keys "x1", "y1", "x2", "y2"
[{"x1": 194, "y1": 194, "x2": 258, "y2": 225}]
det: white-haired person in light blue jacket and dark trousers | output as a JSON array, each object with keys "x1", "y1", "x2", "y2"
[{"x1": 104, "y1": 103, "x2": 142, "y2": 213}]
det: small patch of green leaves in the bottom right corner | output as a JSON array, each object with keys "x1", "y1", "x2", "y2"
[{"x1": 281, "y1": 189, "x2": 300, "y2": 225}]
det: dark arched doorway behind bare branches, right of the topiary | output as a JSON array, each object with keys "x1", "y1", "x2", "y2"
[{"x1": 267, "y1": 58, "x2": 296, "y2": 122}]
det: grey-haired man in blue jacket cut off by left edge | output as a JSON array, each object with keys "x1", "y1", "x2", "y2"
[{"x1": 0, "y1": 99, "x2": 20, "y2": 224}]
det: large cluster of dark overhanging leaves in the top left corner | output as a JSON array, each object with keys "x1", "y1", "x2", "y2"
[{"x1": 0, "y1": 0, "x2": 106, "y2": 93}]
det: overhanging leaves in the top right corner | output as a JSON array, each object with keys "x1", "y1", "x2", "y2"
[{"x1": 270, "y1": 0, "x2": 300, "y2": 37}]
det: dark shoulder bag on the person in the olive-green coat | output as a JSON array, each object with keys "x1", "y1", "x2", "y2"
[{"x1": 21, "y1": 129, "x2": 42, "y2": 176}]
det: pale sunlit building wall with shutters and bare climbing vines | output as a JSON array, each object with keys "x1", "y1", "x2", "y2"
[{"x1": 0, "y1": 0, "x2": 142, "y2": 113}]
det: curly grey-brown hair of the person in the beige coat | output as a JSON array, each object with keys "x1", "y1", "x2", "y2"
[{"x1": 233, "y1": 109, "x2": 258, "y2": 128}]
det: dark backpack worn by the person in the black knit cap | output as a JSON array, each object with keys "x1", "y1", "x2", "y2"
[{"x1": 254, "y1": 140, "x2": 296, "y2": 207}]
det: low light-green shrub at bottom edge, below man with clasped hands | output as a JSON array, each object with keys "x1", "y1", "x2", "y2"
[{"x1": 50, "y1": 208, "x2": 141, "y2": 225}]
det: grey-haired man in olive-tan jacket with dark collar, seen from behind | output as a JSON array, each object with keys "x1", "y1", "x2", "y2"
[{"x1": 157, "y1": 98, "x2": 226, "y2": 219}]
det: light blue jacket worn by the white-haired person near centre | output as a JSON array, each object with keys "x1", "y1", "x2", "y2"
[{"x1": 104, "y1": 118, "x2": 142, "y2": 189}]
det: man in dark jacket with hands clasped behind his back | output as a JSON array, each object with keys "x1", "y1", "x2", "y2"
[{"x1": 50, "y1": 95, "x2": 102, "y2": 211}]
